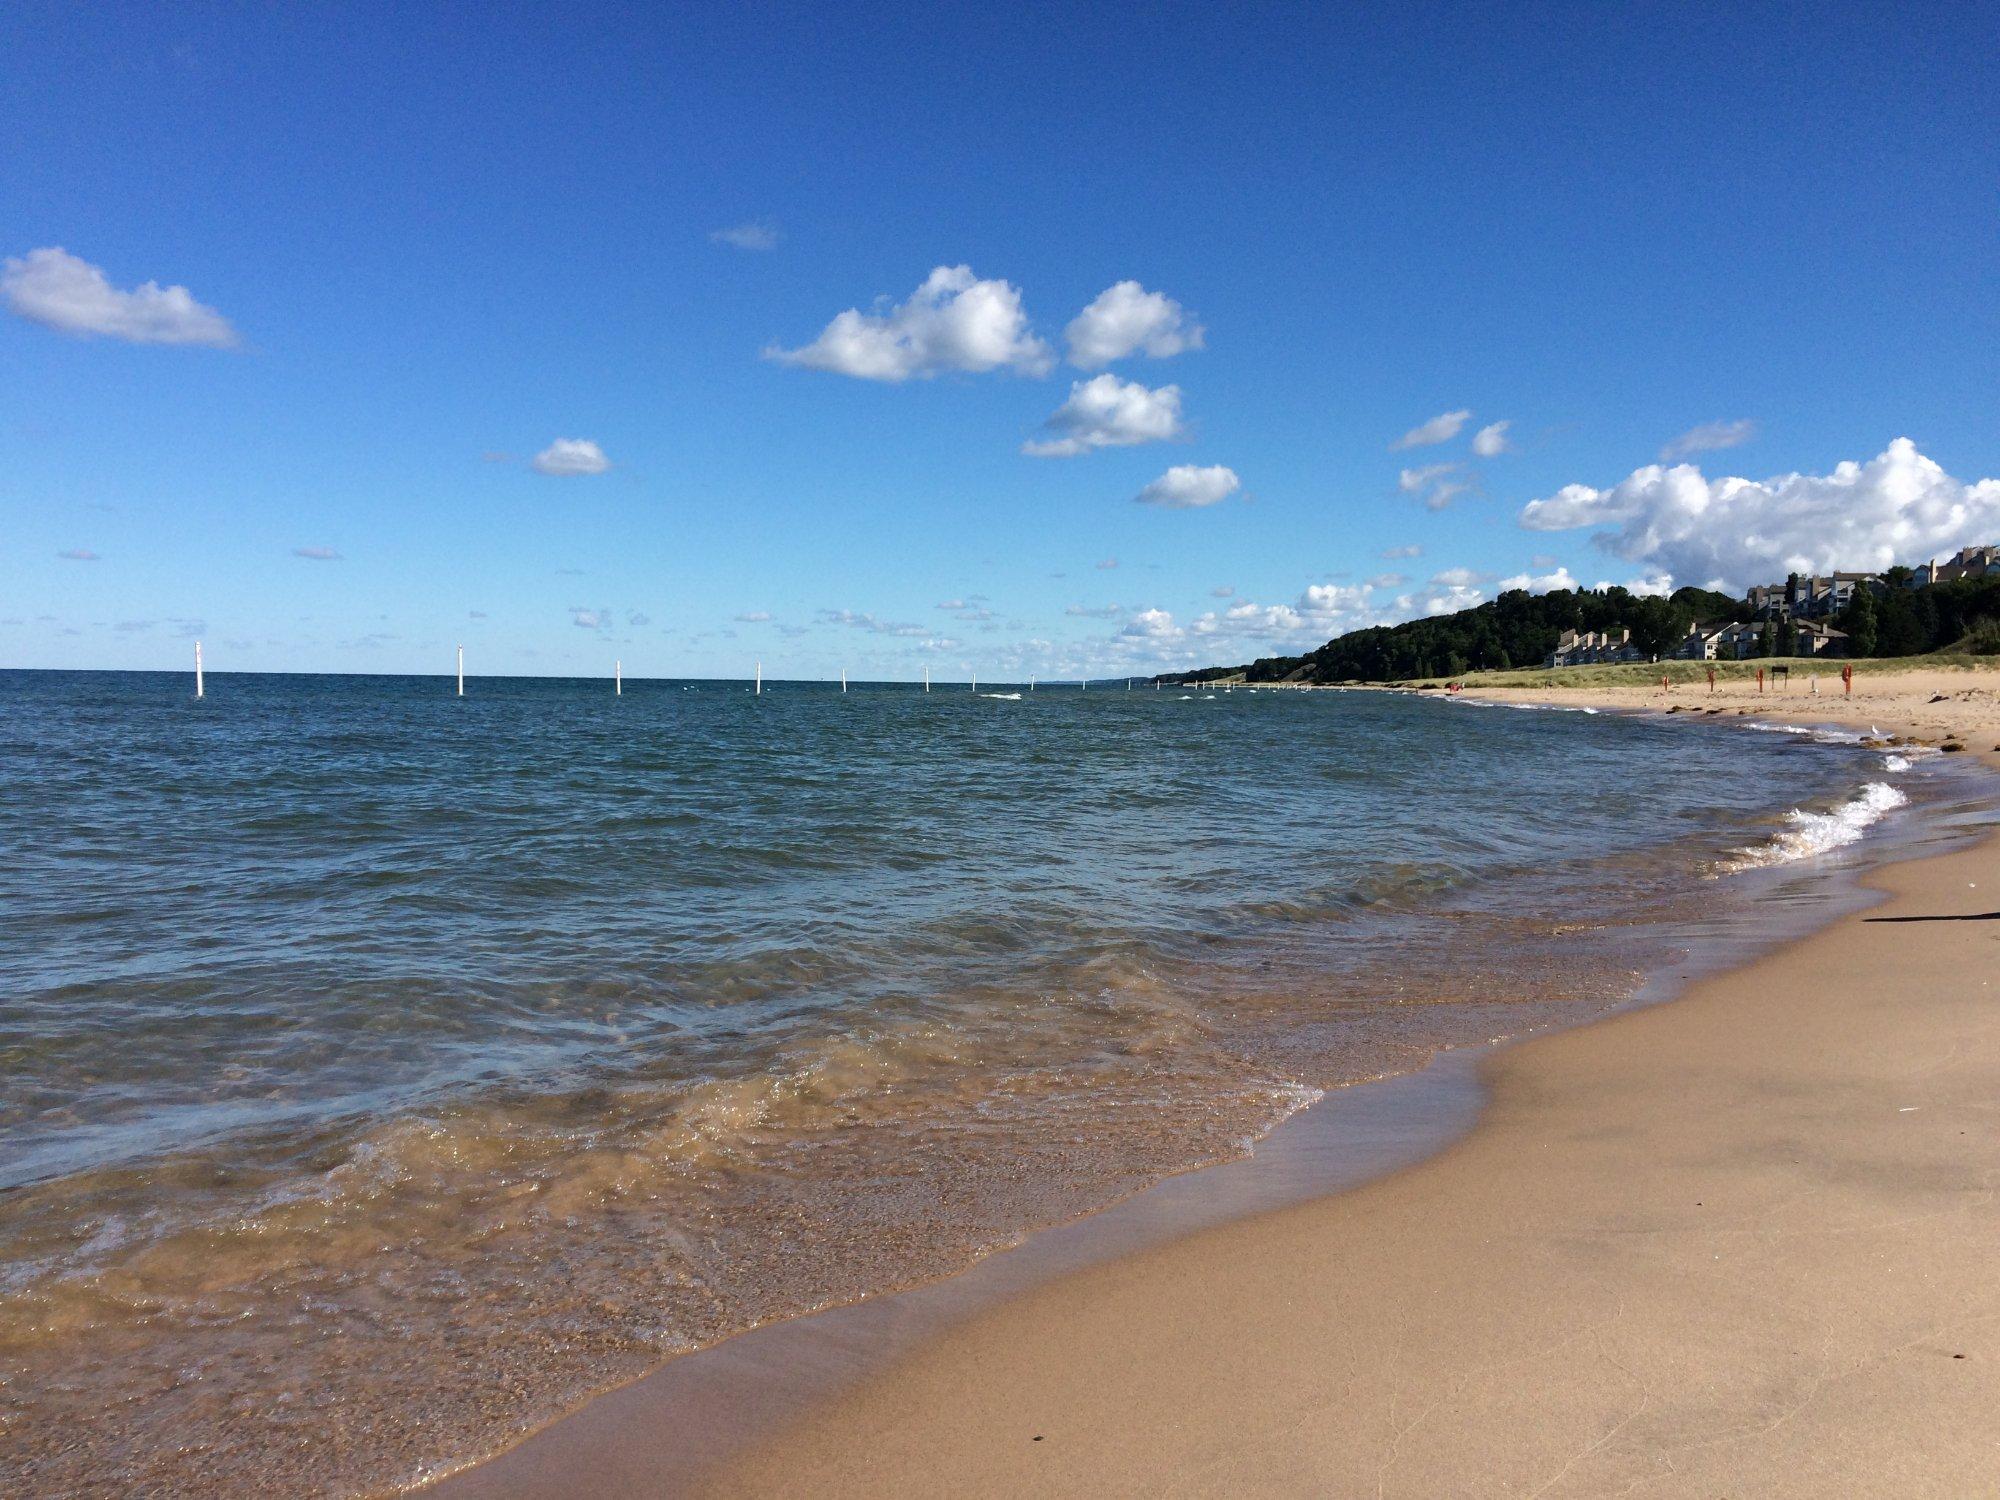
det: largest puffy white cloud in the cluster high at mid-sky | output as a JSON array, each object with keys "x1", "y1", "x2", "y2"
[{"x1": 764, "y1": 266, "x2": 1056, "y2": 382}]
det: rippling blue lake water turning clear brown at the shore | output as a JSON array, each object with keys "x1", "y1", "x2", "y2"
[{"x1": 0, "y1": 674, "x2": 1948, "y2": 1494}]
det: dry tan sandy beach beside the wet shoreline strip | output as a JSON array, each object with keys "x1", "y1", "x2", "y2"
[{"x1": 438, "y1": 672, "x2": 2000, "y2": 1496}]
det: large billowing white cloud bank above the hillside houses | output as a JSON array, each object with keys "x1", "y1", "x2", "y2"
[{"x1": 1520, "y1": 438, "x2": 2000, "y2": 588}]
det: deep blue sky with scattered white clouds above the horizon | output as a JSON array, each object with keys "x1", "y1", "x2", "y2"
[{"x1": 0, "y1": 0, "x2": 2000, "y2": 680}]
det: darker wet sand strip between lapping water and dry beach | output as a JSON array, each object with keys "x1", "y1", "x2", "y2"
[{"x1": 422, "y1": 710, "x2": 2000, "y2": 1500}]
